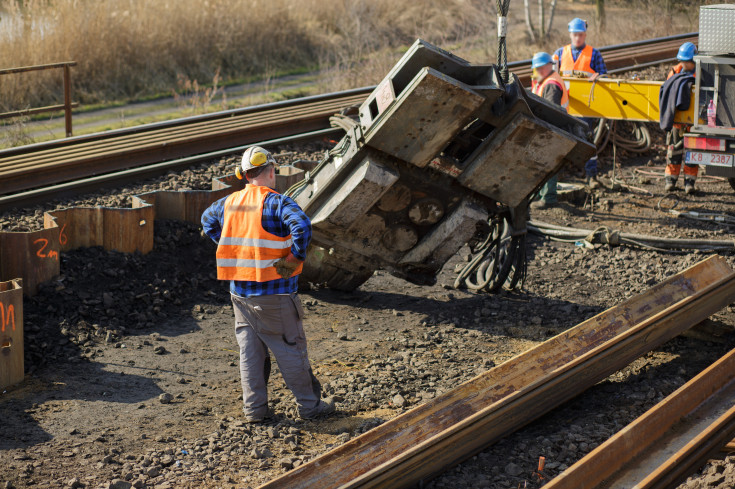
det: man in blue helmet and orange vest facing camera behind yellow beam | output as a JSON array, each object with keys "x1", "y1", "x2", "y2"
[{"x1": 554, "y1": 18, "x2": 607, "y2": 189}]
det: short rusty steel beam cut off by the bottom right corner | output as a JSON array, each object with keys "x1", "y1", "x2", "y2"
[{"x1": 544, "y1": 344, "x2": 735, "y2": 489}]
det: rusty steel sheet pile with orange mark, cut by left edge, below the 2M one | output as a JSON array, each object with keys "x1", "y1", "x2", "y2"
[{"x1": 0, "y1": 279, "x2": 23, "y2": 389}]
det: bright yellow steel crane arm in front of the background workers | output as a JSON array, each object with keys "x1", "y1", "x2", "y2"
[{"x1": 564, "y1": 78, "x2": 694, "y2": 124}]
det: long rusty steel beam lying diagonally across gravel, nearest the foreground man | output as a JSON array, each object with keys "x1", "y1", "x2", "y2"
[{"x1": 262, "y1": 257, "x2": 735, "y2": 489}]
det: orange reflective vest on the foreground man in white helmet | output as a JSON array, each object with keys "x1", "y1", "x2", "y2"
[{"x1": 217, "y1": 185, "x2": 303, "y2": 282}]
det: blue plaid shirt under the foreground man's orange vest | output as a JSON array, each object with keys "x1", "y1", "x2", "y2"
[{"x1": 202, "y1": 186, "x2": 311, "y2": 297}]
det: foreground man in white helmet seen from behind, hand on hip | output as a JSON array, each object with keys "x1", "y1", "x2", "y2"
[{"x1": 202, "y1": 146, "x2": 334, "y2": 423}]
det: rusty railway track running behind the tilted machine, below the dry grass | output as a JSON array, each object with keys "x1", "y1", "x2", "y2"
[{"x1": 0, "y1": 33, "x2": 697, "y2": 210}]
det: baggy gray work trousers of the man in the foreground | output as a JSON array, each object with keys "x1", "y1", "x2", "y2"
[{"x1": 231, "y1": 294, "x2": 322, "y2": 417}]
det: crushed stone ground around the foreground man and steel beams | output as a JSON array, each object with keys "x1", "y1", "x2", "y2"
[{"x1": 0, "y1": 137, "x2": 735, "y2": 489}]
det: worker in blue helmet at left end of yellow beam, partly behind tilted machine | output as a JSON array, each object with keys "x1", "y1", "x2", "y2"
[{"x1": 531, "y1": 52, "x2": 569, "y2": 209}]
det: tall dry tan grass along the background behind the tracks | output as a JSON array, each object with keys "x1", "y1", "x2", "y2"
[{"x1": 0, "y1": 0, "x2": 696, "y2": 111}]
